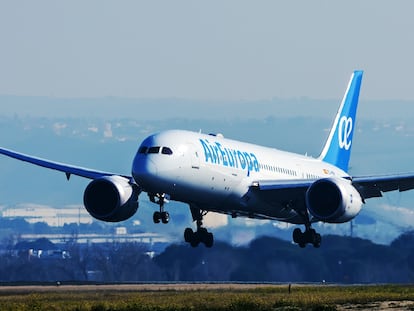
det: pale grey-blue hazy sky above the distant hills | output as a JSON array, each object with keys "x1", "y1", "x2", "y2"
[{"x1": 0, "y1": 0, "x2": 414, "y2": 100}]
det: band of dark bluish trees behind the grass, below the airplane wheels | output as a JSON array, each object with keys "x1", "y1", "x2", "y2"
[{"x1": 0, "y1": 232, "x2": 414, "y2": 283}]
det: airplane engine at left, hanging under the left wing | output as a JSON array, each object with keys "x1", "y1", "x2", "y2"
[{"x1": 83, "y1": 175, "x2": 139, "y2": 222}]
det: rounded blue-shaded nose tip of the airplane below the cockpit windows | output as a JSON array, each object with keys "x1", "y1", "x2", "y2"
[{"x1": 132, "y1": 154, "x2": 158, "y2": 188}]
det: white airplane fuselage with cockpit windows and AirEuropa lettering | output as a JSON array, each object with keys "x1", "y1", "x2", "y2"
[{"x1": 132, "y1": 130, "x2": 348, "y2": 222}]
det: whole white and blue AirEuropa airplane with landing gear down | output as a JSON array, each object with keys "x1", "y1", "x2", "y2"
[{"x1": 0, "y1": 70, "x2": 414, "y2": 248}]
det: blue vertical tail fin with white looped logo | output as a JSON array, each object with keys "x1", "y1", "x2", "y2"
[{"x1": 319, "y1": 71, "x2": 363, "y2": 172}]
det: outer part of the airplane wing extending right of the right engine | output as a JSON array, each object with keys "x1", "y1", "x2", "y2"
[{"x1": 352, "y1": 173, "x2": 414, "y2": 199}]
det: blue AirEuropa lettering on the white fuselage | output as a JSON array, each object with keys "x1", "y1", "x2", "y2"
[{"x1": 200, "y1": 138, "x2": 260, "y2": 172}]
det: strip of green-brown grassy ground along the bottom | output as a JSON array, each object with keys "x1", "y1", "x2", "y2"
[{"x1": 0, "y1": 284, "x2": 414, "y2": 311}]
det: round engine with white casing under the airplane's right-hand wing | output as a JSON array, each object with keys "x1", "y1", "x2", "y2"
[{"x1": 306, "y1": 178, "x2": 363, "y2": 223}]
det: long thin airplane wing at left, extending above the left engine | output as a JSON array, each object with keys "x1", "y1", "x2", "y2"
[{"x1": 0, "y1": 148, "x2": 131, "y2": 179}]
